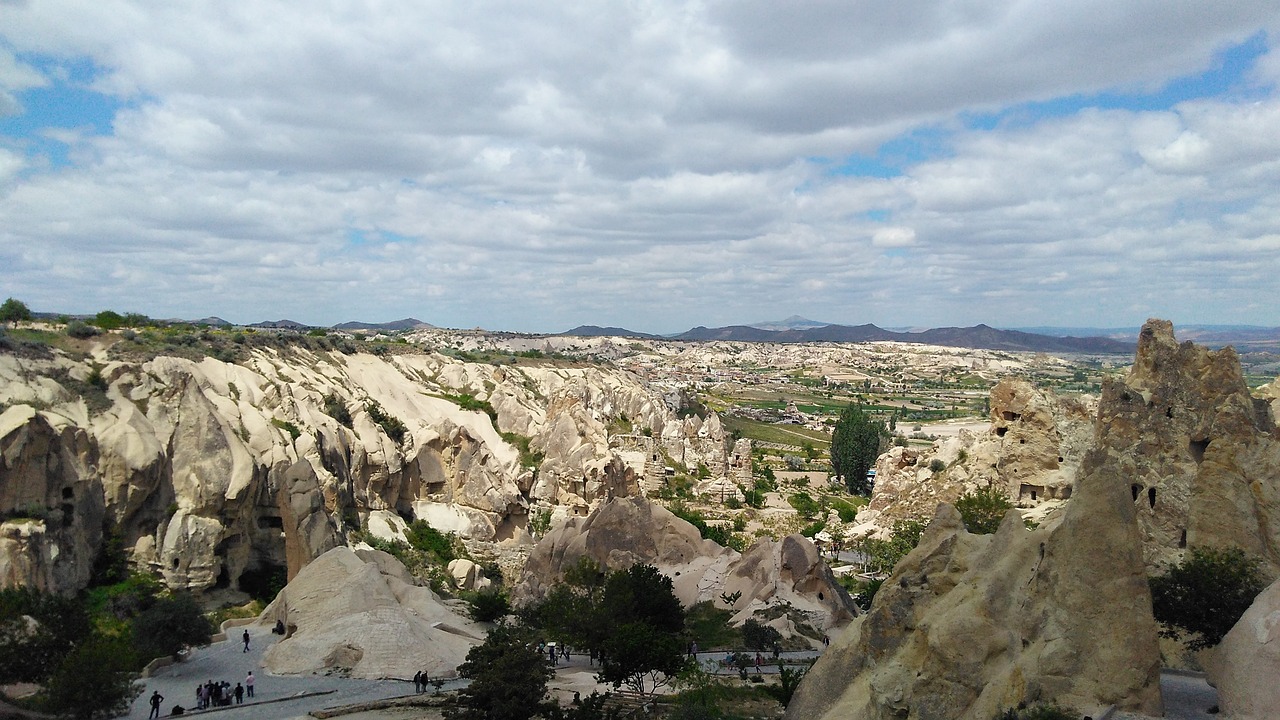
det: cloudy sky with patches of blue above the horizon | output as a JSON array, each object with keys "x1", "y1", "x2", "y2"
[{"x1": 0, "y1": 0, "x2": 1280, "y2": 333}]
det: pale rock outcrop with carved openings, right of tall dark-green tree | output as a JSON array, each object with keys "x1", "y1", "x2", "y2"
[{"x1": 851, "y1": 379, "x2": 1096, "y2": 534}]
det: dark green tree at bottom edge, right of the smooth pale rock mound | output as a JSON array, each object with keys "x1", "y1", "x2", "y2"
[{"x1": 444, "y1": 624, "x2": 554, "y2": 720}]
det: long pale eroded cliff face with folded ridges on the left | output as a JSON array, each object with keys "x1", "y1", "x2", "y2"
[{"x1": 0, "y1": 348, "x2": 724, "y2": 591}]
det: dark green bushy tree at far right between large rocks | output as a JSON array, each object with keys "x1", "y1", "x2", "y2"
[{"x1": 1151, "y1": 547, "x2": 1265, "y2": 650}]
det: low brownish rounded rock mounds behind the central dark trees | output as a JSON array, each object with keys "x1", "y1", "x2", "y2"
[{"x1": 513, "y1": 497, "x2": 854, "y2": 642}]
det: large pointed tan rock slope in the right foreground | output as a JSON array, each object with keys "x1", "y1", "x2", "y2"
[{"x1": 786, "y1": 438, "x2": 1162, "y2": 720}]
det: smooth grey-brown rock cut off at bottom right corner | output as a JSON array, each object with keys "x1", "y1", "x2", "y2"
[{"x1": 1208, "y1": 571, "x2": 1280, "y2": 720}]
